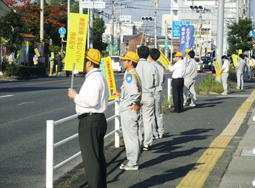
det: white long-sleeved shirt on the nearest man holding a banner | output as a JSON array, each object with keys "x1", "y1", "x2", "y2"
[{"x1": 74, "y1": 68, "x2": 108, "y2": 115}]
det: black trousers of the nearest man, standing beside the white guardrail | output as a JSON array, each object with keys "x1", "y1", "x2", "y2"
[{"x1": 79, "y1": 114, "x2": 107, "y2": 188}]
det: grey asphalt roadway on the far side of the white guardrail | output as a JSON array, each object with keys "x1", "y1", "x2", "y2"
[{"x1": 0, "y1": 73, "x2": 211, "y2": 188}]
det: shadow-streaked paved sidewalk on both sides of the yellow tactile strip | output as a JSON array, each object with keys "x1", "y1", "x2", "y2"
[{"x1": 54, "y1": 81, "x2": 255, "y2": 188}]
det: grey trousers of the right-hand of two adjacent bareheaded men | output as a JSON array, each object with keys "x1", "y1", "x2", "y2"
[{"x1": 153, "y1": 92, "x2": 164, "y2": 137}]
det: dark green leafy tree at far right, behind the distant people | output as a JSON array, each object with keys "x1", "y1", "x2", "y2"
[{"x1": 227, "y1": 18, "x2": 253, "y2": 54}]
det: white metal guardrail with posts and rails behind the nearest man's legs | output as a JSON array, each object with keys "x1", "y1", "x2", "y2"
[{"x1": 46, "y1": 99, "x2": 120, "y2": 188}]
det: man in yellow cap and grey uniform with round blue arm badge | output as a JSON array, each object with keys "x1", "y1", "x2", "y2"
[{"x1": 112, "y1": 51, "x2": 142, "y2": 170}]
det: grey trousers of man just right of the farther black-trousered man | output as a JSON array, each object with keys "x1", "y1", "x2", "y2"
[{"x1": 183, "y1": 78, "x2": 197, "y2": 105}]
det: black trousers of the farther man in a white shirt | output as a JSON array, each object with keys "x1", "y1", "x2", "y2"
[{"x1": 173, "y1": 78, "x2": 184, "y2": 112}]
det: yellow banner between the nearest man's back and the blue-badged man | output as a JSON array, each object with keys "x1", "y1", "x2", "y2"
[{"x1": 99, "y1": 57, "x2": 117, "y2": 100}]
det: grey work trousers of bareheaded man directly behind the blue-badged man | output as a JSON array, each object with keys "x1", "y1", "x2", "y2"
[{"x1": 139, "y1": 94, "x2": 155, "y2": 146}]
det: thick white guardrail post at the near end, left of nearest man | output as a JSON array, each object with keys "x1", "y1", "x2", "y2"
[{"x1": 46, "y1": 120, "x2": 54, "y2": 188}]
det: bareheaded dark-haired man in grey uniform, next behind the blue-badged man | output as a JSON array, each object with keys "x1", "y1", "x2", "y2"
[{"x1": 136, "y1": 46, "x2": 159, "y2": 151}]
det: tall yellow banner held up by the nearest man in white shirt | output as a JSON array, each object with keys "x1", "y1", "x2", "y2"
[{"x1": 65, "y1": 13, "x2": 88, "y2": 72}]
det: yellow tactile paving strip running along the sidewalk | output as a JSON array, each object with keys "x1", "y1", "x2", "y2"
[{"x1": 176, "y1": 90, "x2": 255, "y2": 188}]
